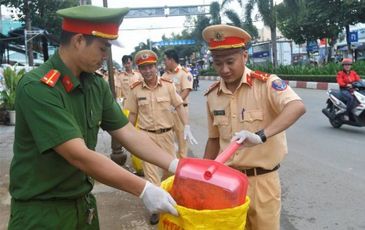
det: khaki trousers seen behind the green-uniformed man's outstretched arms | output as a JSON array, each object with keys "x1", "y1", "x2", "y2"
[{"x1": 141, "y1": 130, "x2": 175, "y2": 186}]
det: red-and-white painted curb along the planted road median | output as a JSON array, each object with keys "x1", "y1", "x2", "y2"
[{"x1": 199, "y1": 76, "x2": 339, "y2": 90}]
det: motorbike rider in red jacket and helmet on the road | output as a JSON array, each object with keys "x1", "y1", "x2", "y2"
[{"x1": 336, "y1": 58, "x2": 361, "y2": 118}]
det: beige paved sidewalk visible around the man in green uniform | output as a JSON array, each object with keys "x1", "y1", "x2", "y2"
[{"x1": 0, "y1": 125, "x2": 157, "y2": 230}]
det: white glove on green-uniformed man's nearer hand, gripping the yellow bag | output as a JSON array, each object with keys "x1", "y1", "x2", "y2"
[{"x1": 139, "y1": 181, "x2": 179, "y2": 216}]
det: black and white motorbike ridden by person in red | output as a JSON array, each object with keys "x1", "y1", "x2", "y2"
[{"x1": 322, "y1": 81, "x2": 365, "y2": 128}]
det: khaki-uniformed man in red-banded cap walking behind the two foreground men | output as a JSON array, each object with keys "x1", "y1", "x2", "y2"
[{"x1": 125, "y1": 50, "x2": 194, "y2": 224}]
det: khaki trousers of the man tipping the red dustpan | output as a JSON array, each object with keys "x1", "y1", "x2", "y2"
[{"x1": 245, "y1": 171, "x2": 281, "y2": 230}]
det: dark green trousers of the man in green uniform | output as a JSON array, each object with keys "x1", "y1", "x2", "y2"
[{"x1": 8, "y1": 194, "x2": 99, "y2": 230}]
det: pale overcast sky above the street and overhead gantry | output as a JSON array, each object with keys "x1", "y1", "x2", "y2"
[{"x1": 92, "y1": 0, "x2": 245, "y2": 63}]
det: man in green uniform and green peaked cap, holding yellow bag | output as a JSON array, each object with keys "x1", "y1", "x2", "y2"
[{"x1": 8, "y1": 6, "x2": 178, "y2": 230}]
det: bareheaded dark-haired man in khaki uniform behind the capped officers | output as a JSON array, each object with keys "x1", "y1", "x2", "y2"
[{"x1": 162, "y1": 49, "x2": 197, "y2": 158}]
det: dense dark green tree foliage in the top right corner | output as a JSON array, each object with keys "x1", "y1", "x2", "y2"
[{"x1": 277, "y1": 0, "x2": 365, "y2": 44}]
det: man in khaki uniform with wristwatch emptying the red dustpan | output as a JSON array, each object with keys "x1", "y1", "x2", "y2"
[{"x1": 203, "y1": 25, "x2": 305, "y2": 230}]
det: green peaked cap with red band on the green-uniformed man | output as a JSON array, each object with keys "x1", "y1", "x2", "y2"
[{"x1": 57, "y1": 5, "x2": 129, "y2": 40}]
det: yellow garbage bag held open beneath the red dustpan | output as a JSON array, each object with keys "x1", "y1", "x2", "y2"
[{"x1": 158, "y1": 176, "x2": 250, "y2": 230}]
